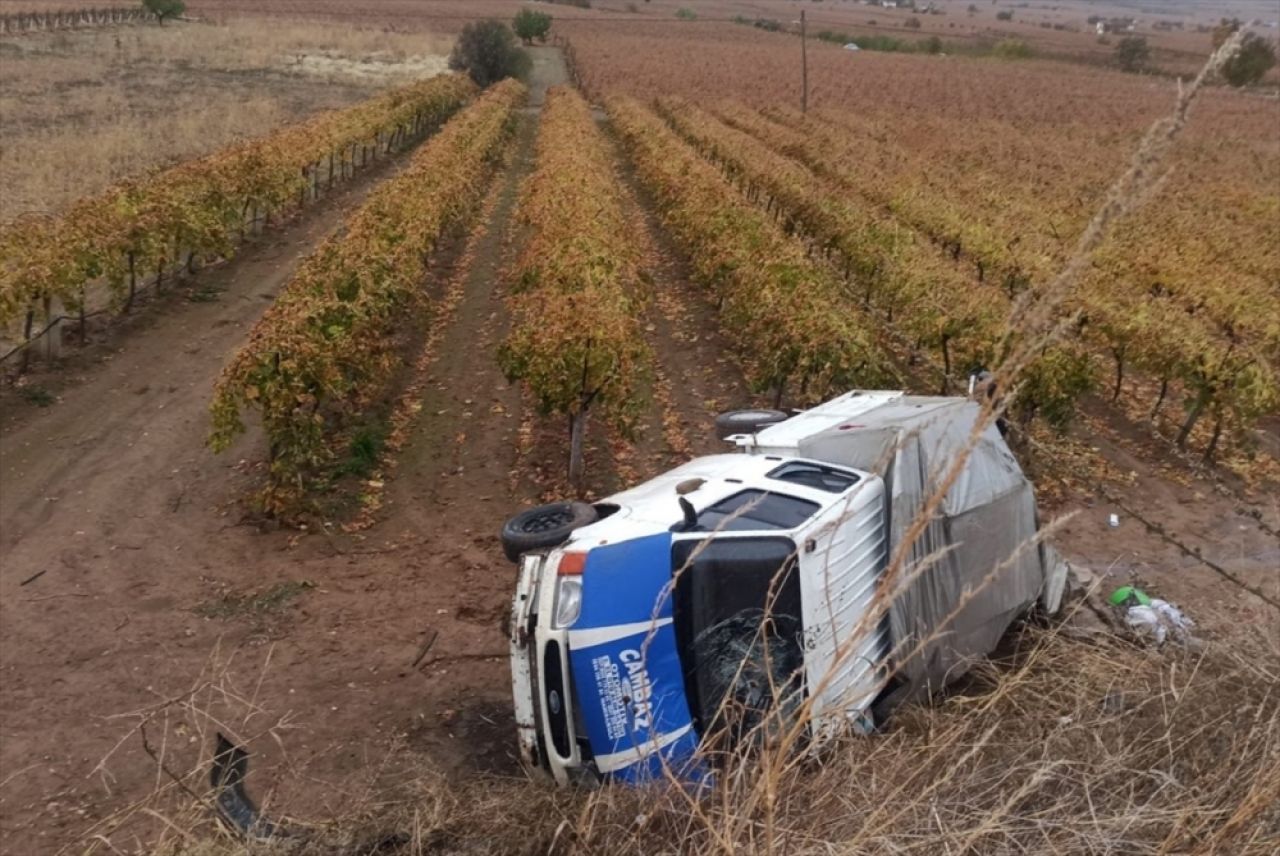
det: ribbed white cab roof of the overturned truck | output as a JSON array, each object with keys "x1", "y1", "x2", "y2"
[{"x1": 771, "y1": 462, "x2": 890, "y2": 724}]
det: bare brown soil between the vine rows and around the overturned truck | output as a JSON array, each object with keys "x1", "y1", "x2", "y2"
[{"x1": 0, "y1": 49, "x2": 1280, "y2": 853}]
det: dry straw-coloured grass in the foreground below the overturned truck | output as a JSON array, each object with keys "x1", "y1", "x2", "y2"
[{"x1": 90, "y1": 616, "x2": 1280, "y2": 856}]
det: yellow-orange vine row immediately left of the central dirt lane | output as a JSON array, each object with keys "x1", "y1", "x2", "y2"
[{"x1": 210, "y1": 81, "x2": 525, "y2": 516}]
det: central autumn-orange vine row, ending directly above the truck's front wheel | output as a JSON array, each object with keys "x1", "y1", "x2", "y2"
[{"x1": 499, "y1": 87, "x2": 653, "y2": 468}]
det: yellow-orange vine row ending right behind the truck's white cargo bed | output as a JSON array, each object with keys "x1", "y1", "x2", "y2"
[{"x1": 607, "y1": 97, "x2": 892, "y2": 399}]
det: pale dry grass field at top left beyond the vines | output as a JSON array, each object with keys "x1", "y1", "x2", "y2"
[{"x1": 0, "y1": 22, "x2": 448, "y2": 221}]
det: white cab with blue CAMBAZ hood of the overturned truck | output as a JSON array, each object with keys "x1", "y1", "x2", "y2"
[{"x1": 511, "y1": 393, "x2": 893, "y2": 783}]
